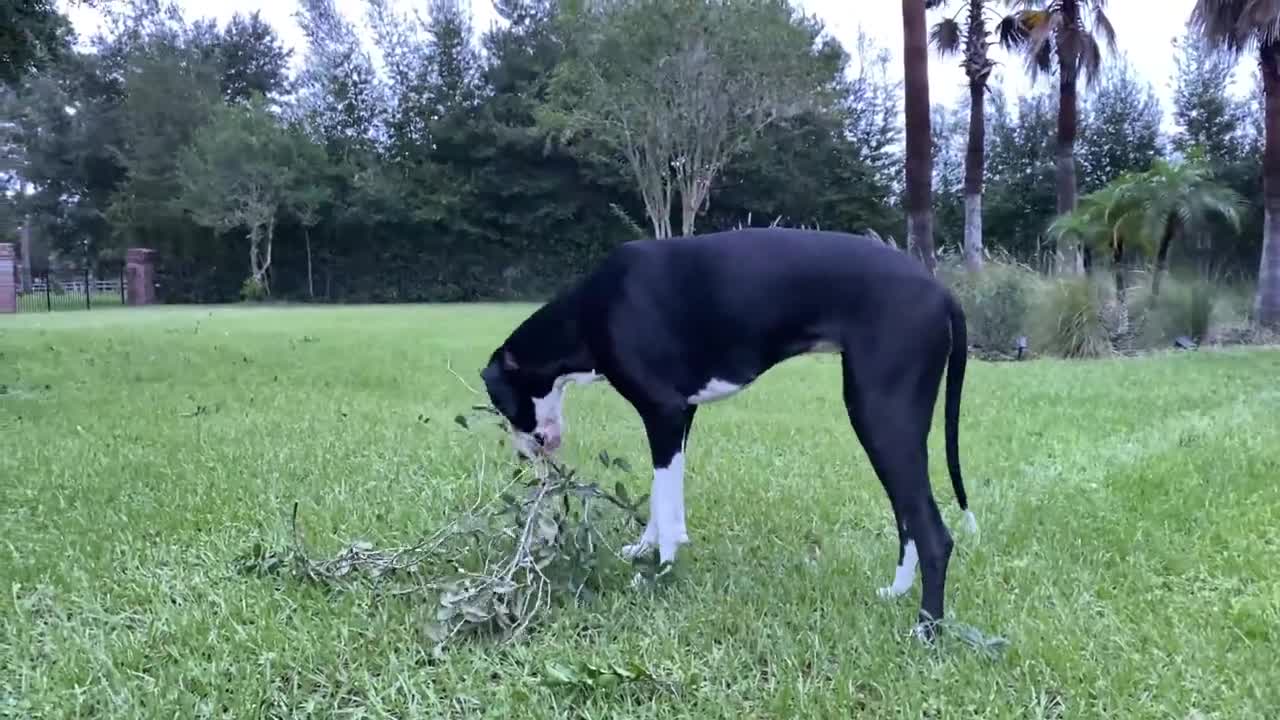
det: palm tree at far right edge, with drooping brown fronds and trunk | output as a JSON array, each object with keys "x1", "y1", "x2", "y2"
[{"x1": 1190, "y1": 0, "x2": 1280, "y2": 328}]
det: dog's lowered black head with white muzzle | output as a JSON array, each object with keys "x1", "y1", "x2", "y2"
[{"x1": 480, "y1": 347, "x2": 562, "y2": 460}]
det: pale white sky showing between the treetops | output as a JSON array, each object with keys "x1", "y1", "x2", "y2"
[{"x1": 60, "y1": 0, "x2": 1252, "y2": 127}]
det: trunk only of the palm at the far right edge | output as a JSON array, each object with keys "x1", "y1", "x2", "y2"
[{"x1": 1254, "y1": 42, "x2": 1280, "y2": 329}]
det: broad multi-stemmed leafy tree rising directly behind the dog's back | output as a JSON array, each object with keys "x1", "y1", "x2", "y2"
[{"x1": 543, "y1": 0, "x2": 849, "y2": 238}]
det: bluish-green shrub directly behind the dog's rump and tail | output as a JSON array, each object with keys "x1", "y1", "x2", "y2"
[{"x1": 942, "y1": 256, "x2": 1044, "y2": 354}]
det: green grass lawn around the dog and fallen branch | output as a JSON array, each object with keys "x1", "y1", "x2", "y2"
[{"x1": 0, "y1": 306, "x2": 1280, "y2": 720}]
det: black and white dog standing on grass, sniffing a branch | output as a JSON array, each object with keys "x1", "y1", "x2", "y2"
[{"x1": 481, "y1": 228, "x2": 975, "y2": 637}]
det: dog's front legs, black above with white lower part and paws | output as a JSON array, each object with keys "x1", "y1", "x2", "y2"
[{"x1": 622, "y1": 411, "x2": 689, "y2": 565}]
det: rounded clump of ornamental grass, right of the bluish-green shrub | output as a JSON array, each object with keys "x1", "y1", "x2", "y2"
[{"x1": 1032, "y1": 275, "x2": 1125, "y2": 357}]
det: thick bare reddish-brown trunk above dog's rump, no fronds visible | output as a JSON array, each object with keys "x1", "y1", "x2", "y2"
[{"x1": 902, "y1": 0, "x2": 937, "y2": 273}]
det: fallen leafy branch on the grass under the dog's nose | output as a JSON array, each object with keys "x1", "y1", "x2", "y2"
[{"x1": 238, "y1": 406, "x2": 648, "y2": 651}]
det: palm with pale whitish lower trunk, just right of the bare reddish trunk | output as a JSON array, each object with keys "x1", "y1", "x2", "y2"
[{"x1": 927, "y1": 0, "x2": 1020, "y2": 270}]
